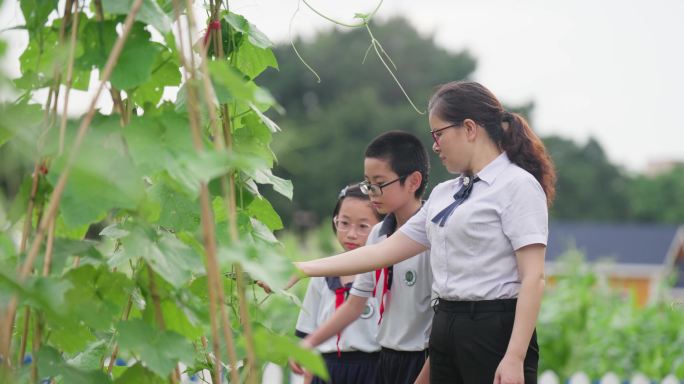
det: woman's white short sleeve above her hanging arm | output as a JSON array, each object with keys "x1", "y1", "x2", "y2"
[{"x1": 501, "y1": 175, "x2": 549, "y2": 251}]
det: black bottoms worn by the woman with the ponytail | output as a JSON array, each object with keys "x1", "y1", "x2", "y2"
[{"x1": 430, "y1": 299, "x2": 539, "y2": 384}]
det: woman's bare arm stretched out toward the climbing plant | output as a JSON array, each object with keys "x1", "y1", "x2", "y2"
[{"x1": 295, "y1": 231, "x2": 427, "y2": 276}]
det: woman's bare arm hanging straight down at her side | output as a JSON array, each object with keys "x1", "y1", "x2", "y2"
[{"x1": 494, "y1": 244, "x2": 546, "y2": 384}]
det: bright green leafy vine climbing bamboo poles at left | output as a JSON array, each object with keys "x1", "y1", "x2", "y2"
[{"x1": 0, "y1": 0, "x2": 326, "y2": 383}]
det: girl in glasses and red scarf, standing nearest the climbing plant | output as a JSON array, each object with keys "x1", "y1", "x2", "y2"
[{"x1": 295, "y1": 184, "x2": 383, "y2": 384}]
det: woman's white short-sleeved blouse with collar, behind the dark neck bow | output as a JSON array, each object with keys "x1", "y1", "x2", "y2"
[{"x1": 399, "y1": 152, "x2": 548, "y2": 300}]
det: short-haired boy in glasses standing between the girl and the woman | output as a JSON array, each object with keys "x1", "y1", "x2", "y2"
[{"x1": 292, "y1": 131, "x2": 434, "y2": 384}]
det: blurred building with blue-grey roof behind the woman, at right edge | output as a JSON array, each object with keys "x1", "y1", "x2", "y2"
[{"x1": 546, "y1": 222, "x2": 684, "y2": 306}]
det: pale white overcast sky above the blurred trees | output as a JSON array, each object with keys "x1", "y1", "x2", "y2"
[{"x1": 0, "y1": 0, "x2": 684, "y2": 170}]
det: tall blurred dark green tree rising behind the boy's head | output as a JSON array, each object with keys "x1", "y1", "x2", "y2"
[{"x1": 262, "y1": 19, "x2": 476, "y2": 224}]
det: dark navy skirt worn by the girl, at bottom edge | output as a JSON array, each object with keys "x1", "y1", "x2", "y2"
[{"x1": 312, "y1": 352, "x2": 380, "y2": 384}]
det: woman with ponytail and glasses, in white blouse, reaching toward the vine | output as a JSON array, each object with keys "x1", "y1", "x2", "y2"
[{"x1": 297, "y1": 82, "x2": 555, "y2": 384}]
